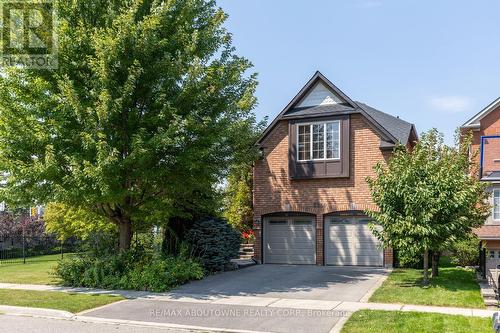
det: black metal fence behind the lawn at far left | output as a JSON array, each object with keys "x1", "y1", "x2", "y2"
[{"x1": 0, "y1": 235, "x2": 78, "y2": 264}]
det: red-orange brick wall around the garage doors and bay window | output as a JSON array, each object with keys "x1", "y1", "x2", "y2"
[{"x1": 254, "y1": 114, "x2": 393, "y2": 266}]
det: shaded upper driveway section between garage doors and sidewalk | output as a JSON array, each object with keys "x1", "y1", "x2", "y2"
[{"x1": 173, "y1": 265, "x2": 388, "y2": 302}]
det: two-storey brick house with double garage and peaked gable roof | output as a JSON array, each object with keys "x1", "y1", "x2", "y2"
[{"x1": 254, "y1": 72, "x2": 418, "y2": 266}]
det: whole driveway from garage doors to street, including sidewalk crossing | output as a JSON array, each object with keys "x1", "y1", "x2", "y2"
[{"x1": 85, "y1": 265, "x2": 388, "y2": 333}]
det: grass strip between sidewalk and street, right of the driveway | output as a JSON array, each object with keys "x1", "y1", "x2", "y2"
[{"x1": 342, "y1": 310, "x2": 493, "y2": 333}]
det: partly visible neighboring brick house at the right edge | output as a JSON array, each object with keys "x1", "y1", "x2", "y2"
[{"x1": 461, "y1": 98, "x2": 500, "y2": 274}]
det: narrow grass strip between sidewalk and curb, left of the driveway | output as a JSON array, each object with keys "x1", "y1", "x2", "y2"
[{"x1": 0, "y1": 289, "x2": 124, "y2": 313}]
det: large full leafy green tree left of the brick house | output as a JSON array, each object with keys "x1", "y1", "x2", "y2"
[{"x1": 0, "y1": 0, "x2": 257, "y2": 250}]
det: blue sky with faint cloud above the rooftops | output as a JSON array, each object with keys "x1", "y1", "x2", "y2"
[{"x1": 218, "y1": 0, "x2": 500, "y2": 143}]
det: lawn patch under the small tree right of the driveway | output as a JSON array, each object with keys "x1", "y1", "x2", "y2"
[{"x1": 370, "y1": 267, "x2": 485, "y2": 308}]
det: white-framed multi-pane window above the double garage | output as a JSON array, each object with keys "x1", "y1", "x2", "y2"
[{"x1": 297, "y1": 120, "x2": 340, "y2": 161}]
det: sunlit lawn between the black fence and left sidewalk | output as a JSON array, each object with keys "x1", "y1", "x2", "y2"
[{"x1": 0, "y1": 254, "x2": 65, "y2": 284}]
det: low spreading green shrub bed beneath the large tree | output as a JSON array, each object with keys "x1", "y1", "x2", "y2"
[{"x1": 55, "y1": 250, "x2": 203, "y2": 292}]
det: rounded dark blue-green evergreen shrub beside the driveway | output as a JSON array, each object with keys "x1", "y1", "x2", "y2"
[{"x1": 186, "y1": 218, "x2": 241, "y2": 272}]
